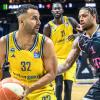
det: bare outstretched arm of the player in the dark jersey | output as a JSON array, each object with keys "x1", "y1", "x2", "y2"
[{"x1": 57, "y1": 37, "x2": 80, "y2": 74}]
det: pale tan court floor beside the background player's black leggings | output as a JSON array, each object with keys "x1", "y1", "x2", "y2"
[{"x1": 56, "y1": 78, "x2": 98, "y2": 100}]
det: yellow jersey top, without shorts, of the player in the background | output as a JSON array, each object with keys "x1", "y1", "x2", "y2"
[{"x1": 49, "y1": 16, "x2": 73, "y2": 59}]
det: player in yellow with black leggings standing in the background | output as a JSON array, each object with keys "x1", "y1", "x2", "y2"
[{"x1": 43, "y1": 2, "x2": 79, "y2": 100}]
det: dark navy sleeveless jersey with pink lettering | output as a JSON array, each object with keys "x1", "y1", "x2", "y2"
[{"x1": 79, "y1": 25, "x2": 100, "y2": 74}]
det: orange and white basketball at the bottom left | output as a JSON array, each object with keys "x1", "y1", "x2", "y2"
[{"x1": 0, "y1": 78, "x2": 24, "y2": 100}]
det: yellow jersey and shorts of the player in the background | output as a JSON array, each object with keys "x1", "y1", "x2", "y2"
[{"x1": 49, "y1": 16, "x2": 76, "y2": 80}]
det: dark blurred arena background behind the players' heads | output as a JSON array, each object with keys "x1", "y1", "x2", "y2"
[{"x1": 0, "y1": 0, "x2": 100, "y2": 36}]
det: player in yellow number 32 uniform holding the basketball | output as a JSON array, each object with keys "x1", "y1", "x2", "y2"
[{"x1": 0, "y1": 4, "x2": 57, "y2": 100}]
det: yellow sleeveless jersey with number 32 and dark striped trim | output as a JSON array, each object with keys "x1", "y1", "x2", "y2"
[{"x1": 7, "y1": 32, "x2": 53, "y2": 91}]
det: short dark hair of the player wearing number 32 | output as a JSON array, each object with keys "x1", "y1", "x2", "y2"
[{"x1": 16, "y1": 4, "x2": 38, "y2": 17}]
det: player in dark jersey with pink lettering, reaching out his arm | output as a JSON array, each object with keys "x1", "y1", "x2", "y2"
[{"x1": 58, "y1": 7, "x2": 100, "y2": 100}]
